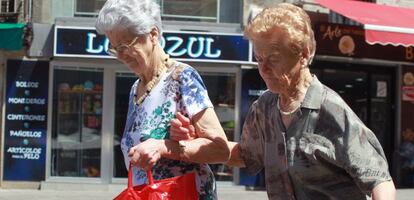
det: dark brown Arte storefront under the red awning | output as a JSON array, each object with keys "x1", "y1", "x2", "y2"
[{"x1": 311, "y1": 24, "x2": 414, "y2": 187}]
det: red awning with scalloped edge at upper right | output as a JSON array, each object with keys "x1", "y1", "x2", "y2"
[{"x1": 314, "y1": 0, "x2": 414, "y2": 46}]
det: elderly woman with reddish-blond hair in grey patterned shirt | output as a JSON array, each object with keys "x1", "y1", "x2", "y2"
[{"x1": 171, "y1": 3, "x2": 395, "y2": 200}]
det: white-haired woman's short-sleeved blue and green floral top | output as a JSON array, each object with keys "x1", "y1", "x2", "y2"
[{"x1": 121, "y1": 62, "x2": 217, "y2": 199}]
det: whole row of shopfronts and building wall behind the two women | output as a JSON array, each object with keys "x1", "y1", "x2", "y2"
[{"x1": 0, "y1": 0, "x2": 414, "y2": 188}]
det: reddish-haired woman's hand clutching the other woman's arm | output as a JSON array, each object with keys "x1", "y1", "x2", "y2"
[{"x1": 170, "y1": 112, "x2": 196, "y2": 142}]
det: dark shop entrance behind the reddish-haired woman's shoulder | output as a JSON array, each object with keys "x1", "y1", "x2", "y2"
[{"x1": 311, "y1": 61, "x2": 395, "y2": 168}]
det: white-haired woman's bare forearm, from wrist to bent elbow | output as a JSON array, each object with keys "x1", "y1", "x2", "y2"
[{"x1": 162, "y1": 138, "x2": 230, "y2": 164}]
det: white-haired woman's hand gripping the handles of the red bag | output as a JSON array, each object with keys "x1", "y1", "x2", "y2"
[{"x1": 128, "y1": 138, "x2": 162, "y2": 169}]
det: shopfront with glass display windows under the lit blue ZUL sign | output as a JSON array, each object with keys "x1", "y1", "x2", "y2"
[{"x1": 39, "y1": 22, "x2": 251, "y2": 183}]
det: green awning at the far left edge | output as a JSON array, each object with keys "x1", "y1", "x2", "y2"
[{"x1": 0, "y1": 23, "x2": 25, "y2": 51}]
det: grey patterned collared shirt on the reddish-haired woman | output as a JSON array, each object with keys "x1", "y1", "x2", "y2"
[{"x1": 240, "y1": 76, "x2": 391, "y2": 200}]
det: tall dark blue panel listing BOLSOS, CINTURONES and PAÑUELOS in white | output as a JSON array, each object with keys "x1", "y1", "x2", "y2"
[{"x1": 3, "y1": 60, "x2": 49, "y2": 181}]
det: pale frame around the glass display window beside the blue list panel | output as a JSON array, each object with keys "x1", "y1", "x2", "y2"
[{"x1": 45, "y1": 58, "x2": 128, "y2": 183}]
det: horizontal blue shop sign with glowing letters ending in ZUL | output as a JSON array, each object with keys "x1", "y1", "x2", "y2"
[{"x1": 54, "y1": 26, "x2": 251, "y2": 63}]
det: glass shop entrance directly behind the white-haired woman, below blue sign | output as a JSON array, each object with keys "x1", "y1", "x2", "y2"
[{"x1": 113, "y1": 66, "x2": 238, "y2": 181}]
